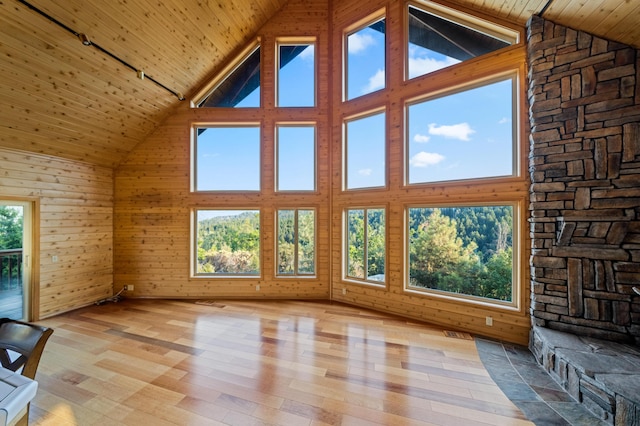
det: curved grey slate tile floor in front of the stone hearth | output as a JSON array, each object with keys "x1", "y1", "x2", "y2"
[{"x1": 476, "y1": 337, "x2": 608, "y2": 426}]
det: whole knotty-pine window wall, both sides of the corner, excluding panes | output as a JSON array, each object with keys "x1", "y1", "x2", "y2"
[{"x1": 114, "y1": 0, "x2": 530, "y2": 343}]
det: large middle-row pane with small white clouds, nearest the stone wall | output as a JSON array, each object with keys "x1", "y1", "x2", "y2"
[{"x1": 407, "y1": 79, "x2": 515, "y2": 184}]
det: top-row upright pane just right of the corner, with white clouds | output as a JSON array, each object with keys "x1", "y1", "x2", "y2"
[{"x1": 346, "y1": 19, "x2": 385, "y2": 100}]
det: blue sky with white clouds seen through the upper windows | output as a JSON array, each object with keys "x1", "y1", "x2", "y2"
[{"x1": 197, "y1": 11, "x2": 515, "y2": 198}]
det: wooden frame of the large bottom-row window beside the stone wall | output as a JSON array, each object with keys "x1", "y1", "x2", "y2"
[{"x1": 403, "y1": 199, "x2": 525, "y2": 312}]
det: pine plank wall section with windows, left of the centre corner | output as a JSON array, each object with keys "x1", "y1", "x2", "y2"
[{"x1": 114, "y1": 0, "x2": 330, "y2": 299}]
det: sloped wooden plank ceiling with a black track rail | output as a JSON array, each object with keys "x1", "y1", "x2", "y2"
[{"x1": 0, "y1": 0, "x2": 640, "y2": 167}]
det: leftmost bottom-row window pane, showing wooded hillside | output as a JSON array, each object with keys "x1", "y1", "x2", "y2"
[{"x1": 196, "y1": 210, "x2": 260, "y2": 275}]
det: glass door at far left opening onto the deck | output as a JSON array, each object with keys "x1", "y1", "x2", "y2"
[{"x1": 0, "y1": 200, "x2": 31, "y2": 320}]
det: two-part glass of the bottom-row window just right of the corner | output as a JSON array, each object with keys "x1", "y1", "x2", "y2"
[{"x1": 345, "y1": 208, "x2": 386, "y2": 284}]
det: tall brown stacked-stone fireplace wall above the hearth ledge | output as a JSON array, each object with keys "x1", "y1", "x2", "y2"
[{"x1": 527, "y1": 17, "x2": 640, "y2": 344}]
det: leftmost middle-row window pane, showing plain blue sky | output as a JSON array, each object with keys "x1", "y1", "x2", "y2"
[{"x1": 196, "y1": 126, "x2": 260, "y2": 191}]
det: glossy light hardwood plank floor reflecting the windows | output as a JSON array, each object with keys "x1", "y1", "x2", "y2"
[{"x1": 30, "y1": 300, "x2": 532, "y2": 426}]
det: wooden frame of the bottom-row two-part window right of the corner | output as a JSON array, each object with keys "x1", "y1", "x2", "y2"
[{"x1": 342, "y1": 205, "x2": 389, "y2": 289}]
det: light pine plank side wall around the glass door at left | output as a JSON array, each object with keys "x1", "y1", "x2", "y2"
[{"x1": 0, "y1": 149, "x2": 113, "y2": 319}]
